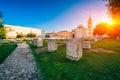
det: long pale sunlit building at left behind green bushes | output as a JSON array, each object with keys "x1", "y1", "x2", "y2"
[{"x1": 4, "y1": 25, "x2": 45, "y2": 38}]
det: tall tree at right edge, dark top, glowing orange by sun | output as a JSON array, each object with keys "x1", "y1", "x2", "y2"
[{"x1": 106, "y1": 0, "x2": 120, "y2": 38}]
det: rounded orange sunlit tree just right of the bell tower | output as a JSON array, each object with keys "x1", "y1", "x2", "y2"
[{"x1": 93, "y1": 23, "x2": 108, "y2": 36}]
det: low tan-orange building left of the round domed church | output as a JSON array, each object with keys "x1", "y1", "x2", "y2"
[{"x1": 56, "y1": 30, "x2": 72, "y2": 38}]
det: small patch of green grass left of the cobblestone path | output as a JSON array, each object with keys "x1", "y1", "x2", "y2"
[{"x1": 0, "y1": 41, "x2": 16, "y2": 64}]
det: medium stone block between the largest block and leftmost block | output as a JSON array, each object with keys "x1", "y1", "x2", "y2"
[{"x1": 48, "y1": 39, "x2": 57, "y2": 52}]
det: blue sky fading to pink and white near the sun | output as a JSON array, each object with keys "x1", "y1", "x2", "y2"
[{"x1": 0, "y1": 0, "x2": 108, "y2": 32}]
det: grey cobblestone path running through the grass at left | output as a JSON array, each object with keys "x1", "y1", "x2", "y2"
[{"x1": 0, "y1": 43, "x2": 41, "y2": 80}]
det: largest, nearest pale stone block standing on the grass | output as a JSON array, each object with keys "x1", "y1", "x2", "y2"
[{"x1": 66, "y1": 39, "x2": 83, "y2": 61}]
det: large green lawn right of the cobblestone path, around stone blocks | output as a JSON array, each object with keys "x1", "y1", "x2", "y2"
[{"x1": 30, "y1": 39, "x2": 120, "y2": 80}]
